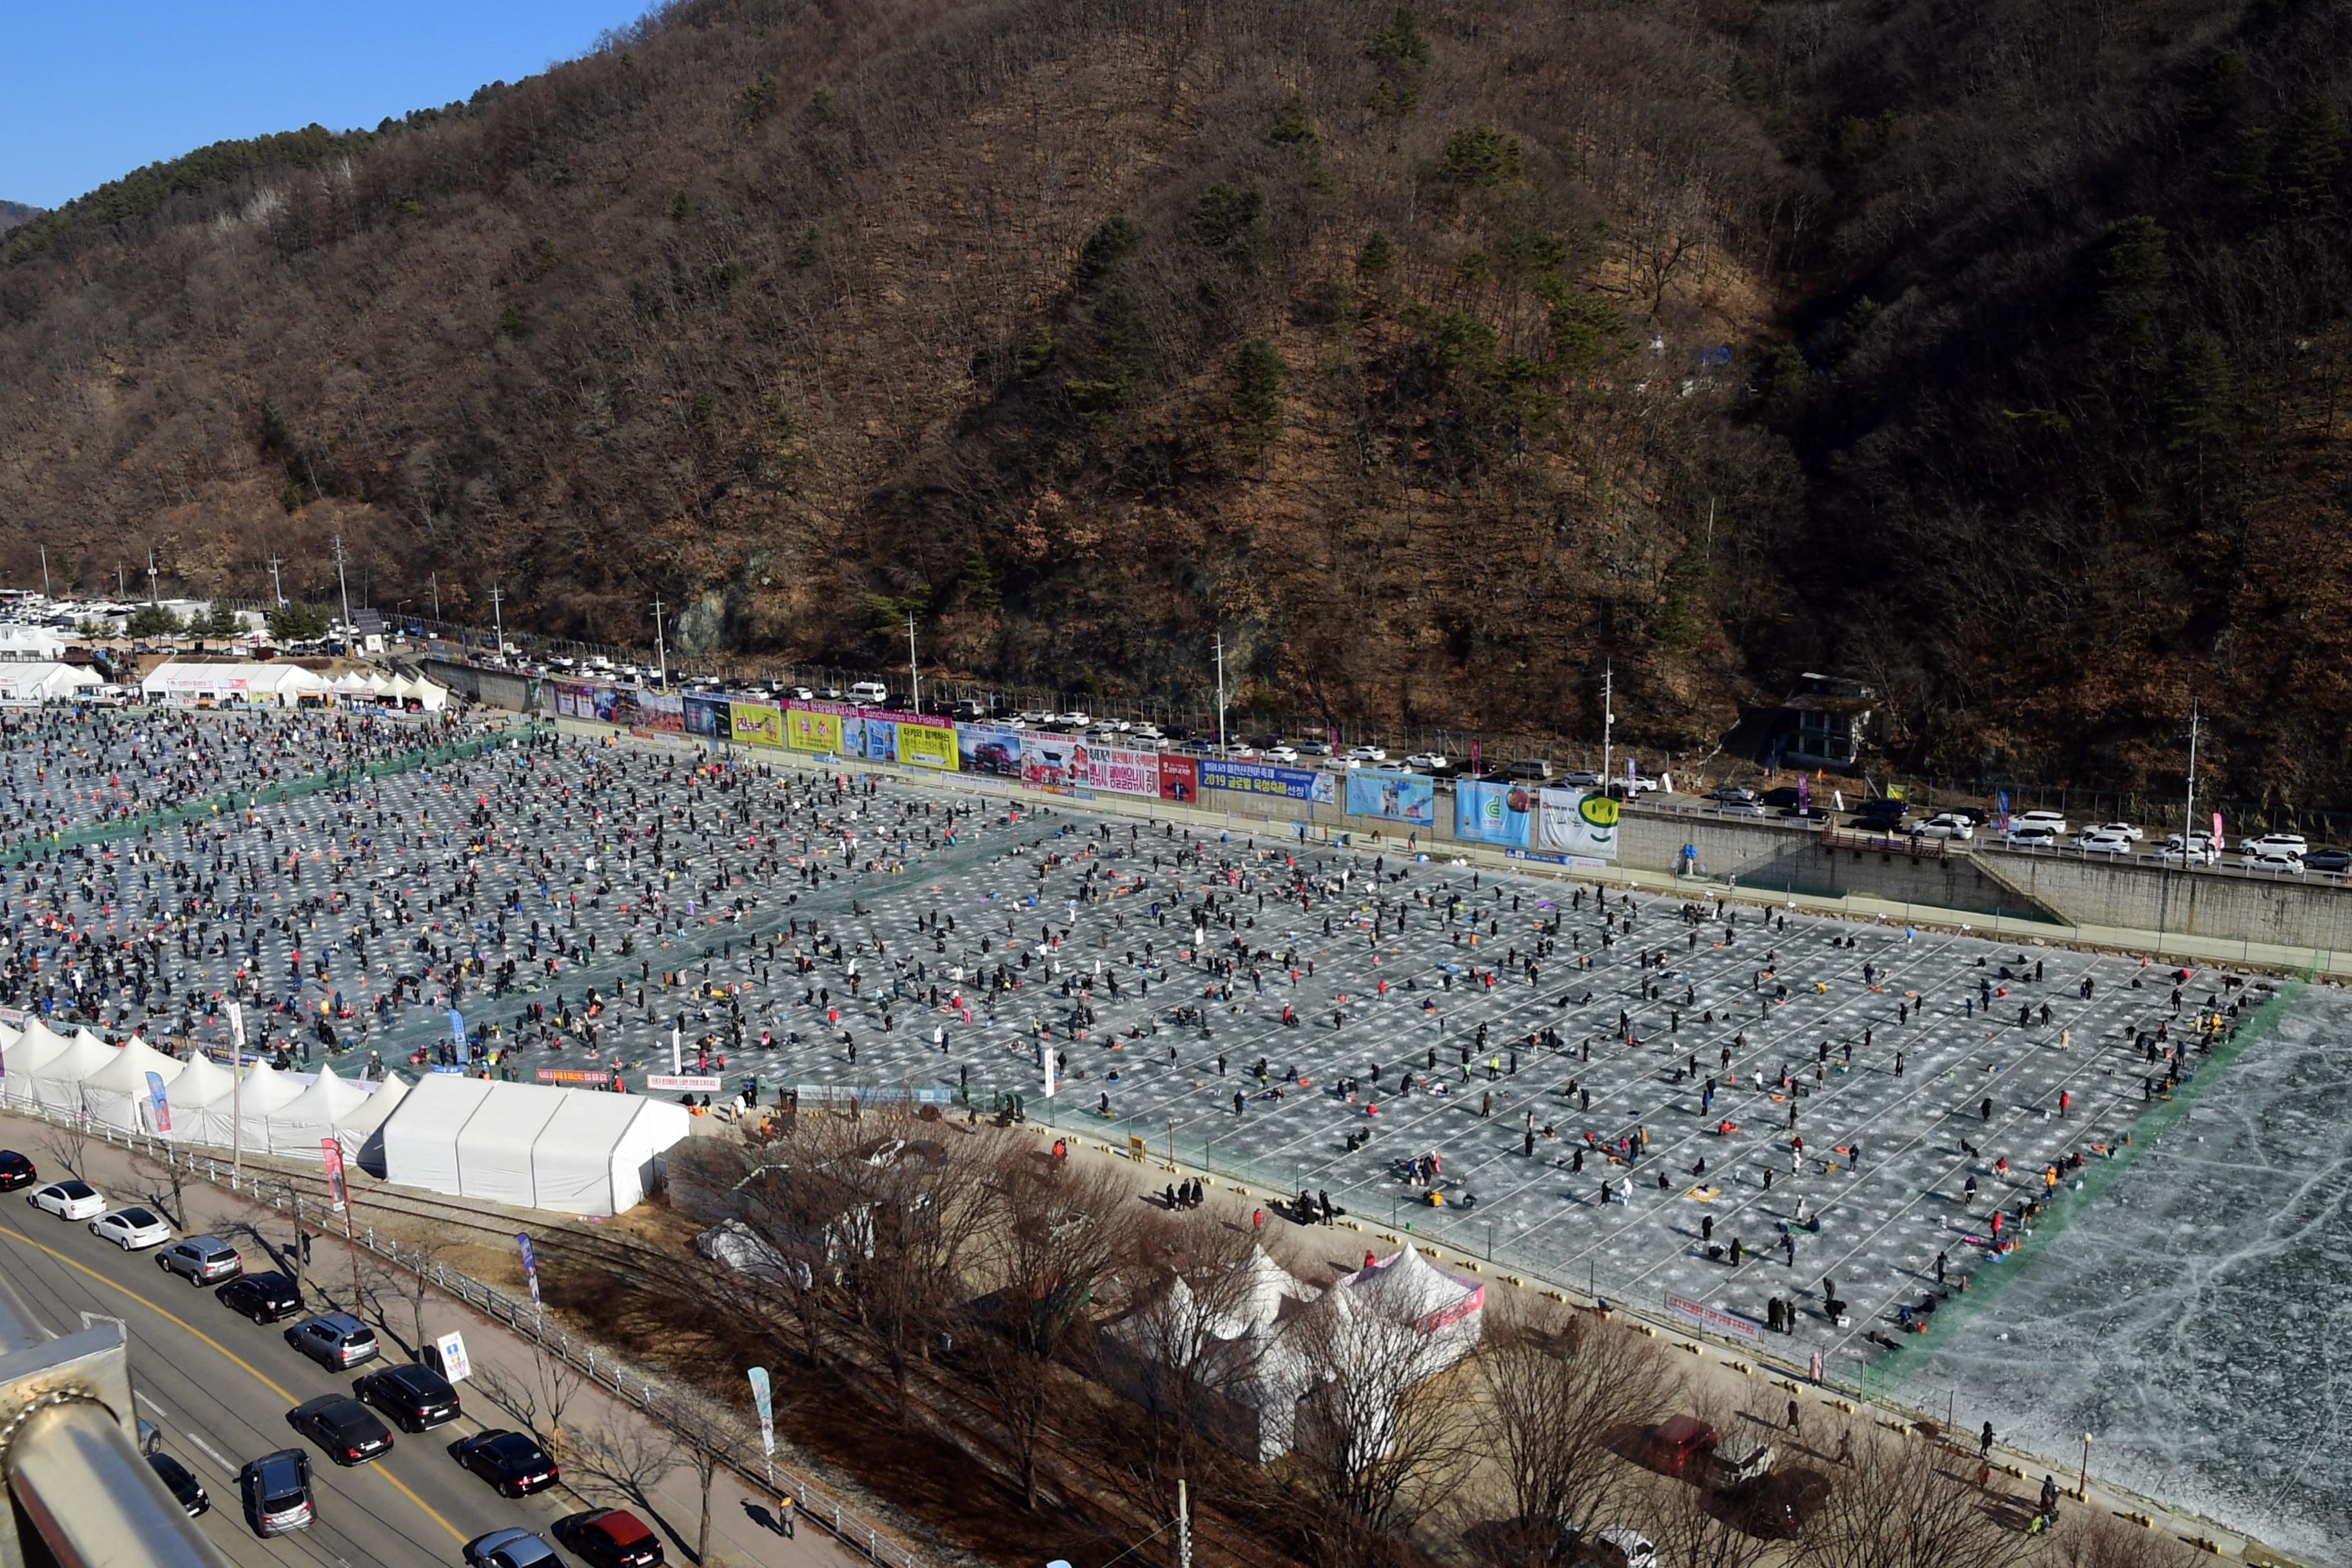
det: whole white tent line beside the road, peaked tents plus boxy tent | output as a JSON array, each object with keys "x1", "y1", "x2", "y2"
[{"x1": 0, "y1": 1018, "x2": 694, "y2": 1215}]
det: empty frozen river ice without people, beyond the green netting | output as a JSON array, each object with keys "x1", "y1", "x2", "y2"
[{"x1": 1908, "y1": 987, "x2": 2352, "y2": 1563}]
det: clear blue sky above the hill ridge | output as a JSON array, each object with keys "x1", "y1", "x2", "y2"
[{"x1": 0, "y1": 0, "x2": 649, "y2": 207}]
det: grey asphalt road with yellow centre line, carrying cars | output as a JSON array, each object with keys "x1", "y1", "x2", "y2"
[{"x1": 0, "y1": 1204, "x2": 581, "y2": 1568}]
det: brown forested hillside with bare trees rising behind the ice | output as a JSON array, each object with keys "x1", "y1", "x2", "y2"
[{"x1": 0, "y1": 0, "x2": 2352, "y2": 801}]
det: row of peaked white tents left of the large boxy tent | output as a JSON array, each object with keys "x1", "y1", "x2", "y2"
[{"x1": 0, "y1": 1018, "x2": 407, "y2": 1161}]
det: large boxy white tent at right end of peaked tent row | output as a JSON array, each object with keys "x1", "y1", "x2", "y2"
[{"x1": 384, "y1": 1072, "x2": 694, "y2": 1215}]
